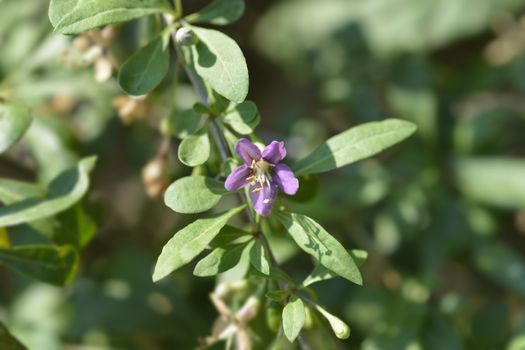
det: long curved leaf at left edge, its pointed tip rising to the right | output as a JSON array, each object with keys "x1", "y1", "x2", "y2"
[{"x1": 0, "y1": 157, "x2": 96, "y2": 227}]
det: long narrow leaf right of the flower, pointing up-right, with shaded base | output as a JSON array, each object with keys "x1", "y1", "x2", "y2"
[{"x1": 293, "y1": 119, "x2": 416, "y2": 176}]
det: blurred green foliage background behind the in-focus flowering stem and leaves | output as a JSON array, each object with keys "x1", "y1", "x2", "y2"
[{"x1": 0, "y1": 0, "x2": 525, "y2": 350}]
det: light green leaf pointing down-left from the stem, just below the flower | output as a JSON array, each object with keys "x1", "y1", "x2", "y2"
[{"x1": 153, "y1": 205, "x2": 246, "y2": 282}]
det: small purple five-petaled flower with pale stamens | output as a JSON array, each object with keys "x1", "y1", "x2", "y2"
[{"x1": 224, "y1": 139, "x2": 299, "y2": 216}]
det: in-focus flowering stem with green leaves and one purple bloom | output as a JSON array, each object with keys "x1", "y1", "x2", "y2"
[{"x1": 49, "y1": 0, "x2": 415, "y2": 349}]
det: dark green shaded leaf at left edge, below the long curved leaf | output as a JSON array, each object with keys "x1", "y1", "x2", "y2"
[{"x1": 0, "y1": 245, "x2": 78, "y2": 285}]
